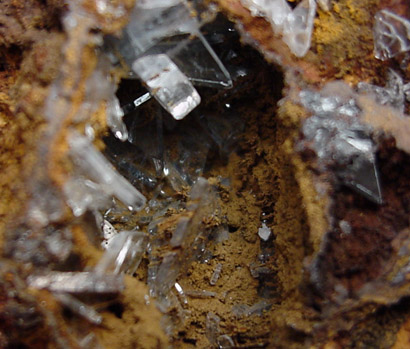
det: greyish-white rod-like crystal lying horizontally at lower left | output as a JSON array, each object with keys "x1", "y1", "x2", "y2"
[{"x1": 27, "y1": 271, "x2": 124, "y2": 293}]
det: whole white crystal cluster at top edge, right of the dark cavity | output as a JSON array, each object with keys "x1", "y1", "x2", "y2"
[{"x1": 241, "y1": 0, "x2": 318, "y2": 57}]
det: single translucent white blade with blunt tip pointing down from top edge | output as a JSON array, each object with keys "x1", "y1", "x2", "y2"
[{"x1": 283, "y1": 0, "x2": 316, "y2": 57}]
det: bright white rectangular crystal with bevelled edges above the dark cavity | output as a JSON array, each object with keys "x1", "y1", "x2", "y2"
[{"x1": 132, "y1": 54, "x2": 201, "y2": 120}]
